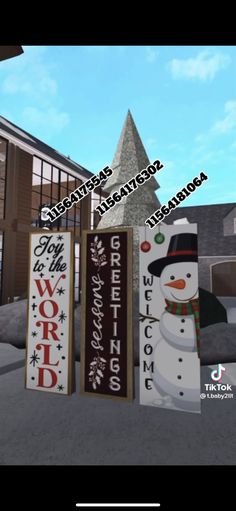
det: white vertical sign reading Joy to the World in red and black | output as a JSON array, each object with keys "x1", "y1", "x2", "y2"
[{"x1": 26, "y1": 231, "x2": 73, "y2": 394}]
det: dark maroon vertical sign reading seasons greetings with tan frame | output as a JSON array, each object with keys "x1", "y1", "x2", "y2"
[{"x1": 81, "y1": 229, "x2": 133, "y2": 401}]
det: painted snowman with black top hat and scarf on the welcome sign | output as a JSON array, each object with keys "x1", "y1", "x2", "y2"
[{"x1": 148, "y1": 233, "x2": 200, "y2": 412}]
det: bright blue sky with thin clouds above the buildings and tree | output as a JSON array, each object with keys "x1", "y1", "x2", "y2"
[{"x1": 0, "y1": 46, "x2": 236, "y2": 206}]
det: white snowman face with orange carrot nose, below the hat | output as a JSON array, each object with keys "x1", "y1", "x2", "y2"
[{"x1": 160, "y1": 262, "x2": 198, "y2": 303}]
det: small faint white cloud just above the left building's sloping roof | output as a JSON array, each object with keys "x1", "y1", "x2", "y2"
[{"x1": 22, "y1": 107, "x2": 70, "y2": 135}]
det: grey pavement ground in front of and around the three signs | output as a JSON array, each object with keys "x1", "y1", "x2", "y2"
[{"x1": 0, "y1": 345, "x2": 236, "y2": 465}]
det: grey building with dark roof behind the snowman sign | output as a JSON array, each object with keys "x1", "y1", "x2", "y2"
[{"x1": 166, "y1": 203, "x2": 236, "y2": 305}]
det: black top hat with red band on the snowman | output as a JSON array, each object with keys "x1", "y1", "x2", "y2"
[{"x1": 148, "y1": 232, "x2": 198, "y2": 277}]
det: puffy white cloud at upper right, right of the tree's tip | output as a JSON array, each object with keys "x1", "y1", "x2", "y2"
[{"x1": 168, "y1": 51, "x2": 231, "y2": 82}]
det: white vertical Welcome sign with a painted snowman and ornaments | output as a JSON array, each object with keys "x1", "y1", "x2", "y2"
[{"x1": 139, "y1": 224, "x2": 200, "y2": 413}]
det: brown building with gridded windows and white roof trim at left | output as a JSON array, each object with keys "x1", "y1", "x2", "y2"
[{"x1": 0, "y1": 117, "x2": 102, "y2": 305}]
